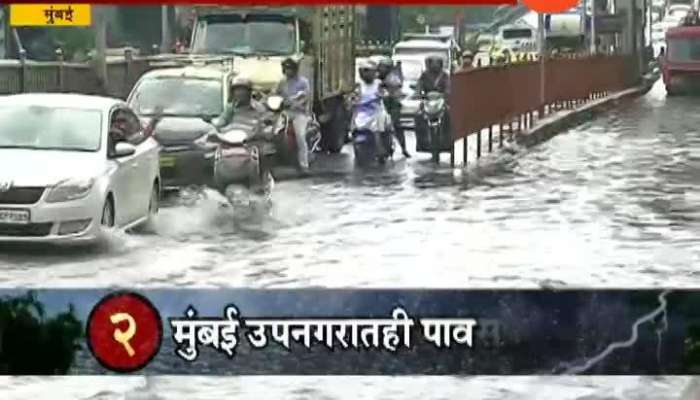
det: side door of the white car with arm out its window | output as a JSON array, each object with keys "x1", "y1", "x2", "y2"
[{"x1": 122, "y1": 108, "x2": 160, "y2": 219}]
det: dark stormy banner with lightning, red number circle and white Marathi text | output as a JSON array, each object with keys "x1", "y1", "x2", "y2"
[{"x1": 0, "y1": 289, "x2": 700, "y2": 375}]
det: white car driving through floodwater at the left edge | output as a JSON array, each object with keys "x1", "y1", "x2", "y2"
[{"x1": 0, "y1": 93, "x2": 160, "y2": 242}]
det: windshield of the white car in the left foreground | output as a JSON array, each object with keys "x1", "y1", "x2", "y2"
[{"x1": 0, "y1": 105, "x2": 102, "y2": 152}]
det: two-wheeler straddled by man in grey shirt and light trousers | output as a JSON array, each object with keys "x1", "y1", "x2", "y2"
[{"x1": 265, "y1": 95, "x2": 321, "y2": 167}]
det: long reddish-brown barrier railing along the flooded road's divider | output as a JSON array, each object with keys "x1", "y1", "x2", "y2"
[{"x1": 450, "y1": 55, "x2": 639, "y2": 165}]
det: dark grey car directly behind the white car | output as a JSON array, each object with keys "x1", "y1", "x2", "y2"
[{"x1": 127, "y1": 65, "x2": 234, "y2": 189}]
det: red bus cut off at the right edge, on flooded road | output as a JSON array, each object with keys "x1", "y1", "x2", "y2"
[{"x1": 661, "y1": 26, "x2": 700, "y2": 95}]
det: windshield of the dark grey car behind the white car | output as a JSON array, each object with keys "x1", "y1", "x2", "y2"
[{"x1": 132, "y1": 77, "x2": 224, "y2": 117}]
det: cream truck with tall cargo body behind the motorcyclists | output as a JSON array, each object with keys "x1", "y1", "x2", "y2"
[{"x1": 189, "y1": 6, "x2": 356, "y2": 153}]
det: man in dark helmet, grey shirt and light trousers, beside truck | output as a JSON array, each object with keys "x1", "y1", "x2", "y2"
[{"x1": 276, "y1": 58, "x2": 311, "y2": 175}]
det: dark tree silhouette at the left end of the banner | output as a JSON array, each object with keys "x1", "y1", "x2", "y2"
[{"x1": 0, "y1": 292, "x2": 83, "y2": 375}]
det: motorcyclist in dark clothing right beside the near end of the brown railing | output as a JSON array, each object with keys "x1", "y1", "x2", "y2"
[{"x1": 415, "y1": 56, "x2": 450, "y2": 152}]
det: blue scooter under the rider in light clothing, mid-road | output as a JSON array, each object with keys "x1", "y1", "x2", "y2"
[{"x1": 350, "y1": 90, "x2": 394, "y2": 166}]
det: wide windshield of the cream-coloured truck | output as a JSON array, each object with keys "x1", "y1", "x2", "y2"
[{"x1": 194, "y1": 20, "x2": 296, "y2": 56}]
